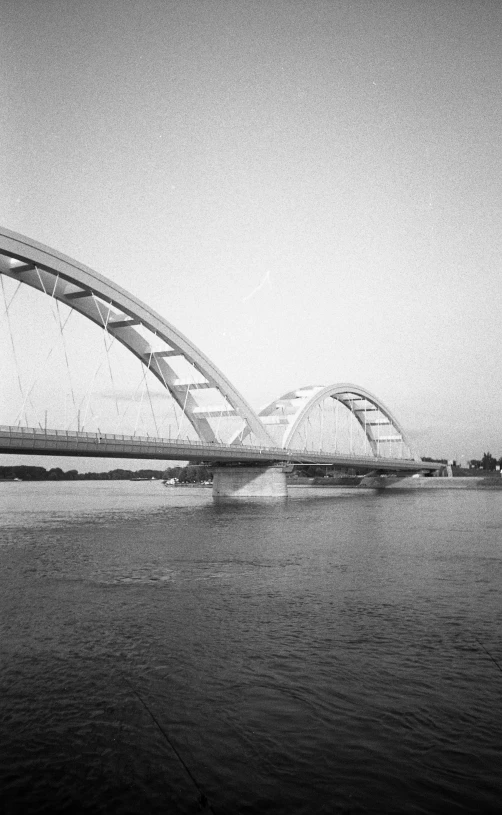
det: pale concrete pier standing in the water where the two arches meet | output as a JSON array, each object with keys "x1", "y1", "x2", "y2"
[{"x1": 213, "y1": 465, "x2": 288, "y2": 501}]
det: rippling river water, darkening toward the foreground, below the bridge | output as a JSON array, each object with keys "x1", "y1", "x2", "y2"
[{"x1": 0, "y1": 482, "x2": 502, "y2": 815}]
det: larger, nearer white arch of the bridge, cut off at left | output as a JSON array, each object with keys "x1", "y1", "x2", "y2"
[{"x1": 0, "y1": 228, "x2": 273, "y2": 446}]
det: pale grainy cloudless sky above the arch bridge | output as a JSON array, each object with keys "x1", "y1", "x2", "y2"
[{"x1": 0, "y1": 0, "x2": 502, "y2": 469}]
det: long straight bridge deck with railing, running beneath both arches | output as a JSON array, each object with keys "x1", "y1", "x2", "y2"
[{"x1": 0, "y1": 426, "x2": 442, "y2": 473}]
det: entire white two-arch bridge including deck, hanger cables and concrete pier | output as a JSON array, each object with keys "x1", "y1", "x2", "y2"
[{"x1": 0, "y1": 229, "x2": 442, "y2": 498}]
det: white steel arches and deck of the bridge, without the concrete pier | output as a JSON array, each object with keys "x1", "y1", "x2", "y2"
[{"x1": 0, "y1": 228, "x2": 439, "y2": 473}]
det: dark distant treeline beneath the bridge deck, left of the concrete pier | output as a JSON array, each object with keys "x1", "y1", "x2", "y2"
[{"x1": 0, "y1": 464, "x2": 212, "y2": 483}]
